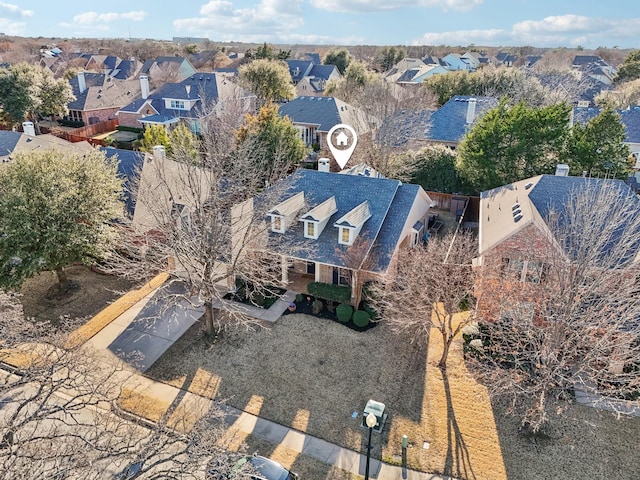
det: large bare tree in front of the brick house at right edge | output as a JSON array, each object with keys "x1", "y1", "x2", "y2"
[{"x1": 467, "y1": 180, "x2": 640, "y2": 431}]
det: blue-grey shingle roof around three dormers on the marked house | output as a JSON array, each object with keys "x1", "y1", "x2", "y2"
[{"x1": 256, "y1": 169, "x2": 408, "y2": 272}]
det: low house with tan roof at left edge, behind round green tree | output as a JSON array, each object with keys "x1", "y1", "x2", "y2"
[{"x1": 0, "y1": 126, "x2": 93, "y2": 163}]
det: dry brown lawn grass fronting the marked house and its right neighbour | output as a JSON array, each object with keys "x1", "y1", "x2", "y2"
[{"x1": 148, "y1": 315, "x2": 640, "y2": 480}]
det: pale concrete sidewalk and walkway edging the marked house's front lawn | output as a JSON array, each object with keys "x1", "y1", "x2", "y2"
[{"x1": 85, "y1": 284, "x2": 451, "y2": 480}]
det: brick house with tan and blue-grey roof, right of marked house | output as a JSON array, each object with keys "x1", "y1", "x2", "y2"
[{"x1": 474, "y1": 169, "x2": 640, "y2": 315}]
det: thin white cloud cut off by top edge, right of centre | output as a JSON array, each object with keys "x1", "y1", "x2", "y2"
[{"x1": 309, "y1": 0, "x2": 484, "y2": 12}]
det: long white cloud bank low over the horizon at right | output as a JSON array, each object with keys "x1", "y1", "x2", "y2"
[{"x1": 412, "y1": 15, "x2": 640, "y2": 48}]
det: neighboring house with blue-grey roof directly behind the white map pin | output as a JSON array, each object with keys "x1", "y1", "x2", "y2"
[{"x1": 278, "y1": 96, "x2": 378, "y2": 149}]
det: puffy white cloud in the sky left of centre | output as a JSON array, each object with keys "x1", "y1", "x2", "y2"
[{"x1": 173, "y1": 0, "x2": 304, "y2": 42}]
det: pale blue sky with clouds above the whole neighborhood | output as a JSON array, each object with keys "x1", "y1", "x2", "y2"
[{"x1": 0, "y1": 0, "x2": 640, "y2": 48}]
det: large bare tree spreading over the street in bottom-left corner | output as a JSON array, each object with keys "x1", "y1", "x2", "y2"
[{"x1": 0, "y1": 293, "x2": 245, "y2": 480}]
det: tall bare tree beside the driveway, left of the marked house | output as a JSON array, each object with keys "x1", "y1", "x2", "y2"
[{"x1": 107, "y1": 109, "x2": 304, "y2": 333}]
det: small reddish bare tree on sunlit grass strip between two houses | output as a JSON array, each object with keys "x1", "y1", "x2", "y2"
[{"x1": 372, "y1": 231, "x2": 476, "y2": 369}]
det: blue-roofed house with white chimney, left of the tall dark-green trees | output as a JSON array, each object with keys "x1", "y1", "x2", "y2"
[{"x1": 422, "y1": 95, "x2": 498, "y2": 148}]
